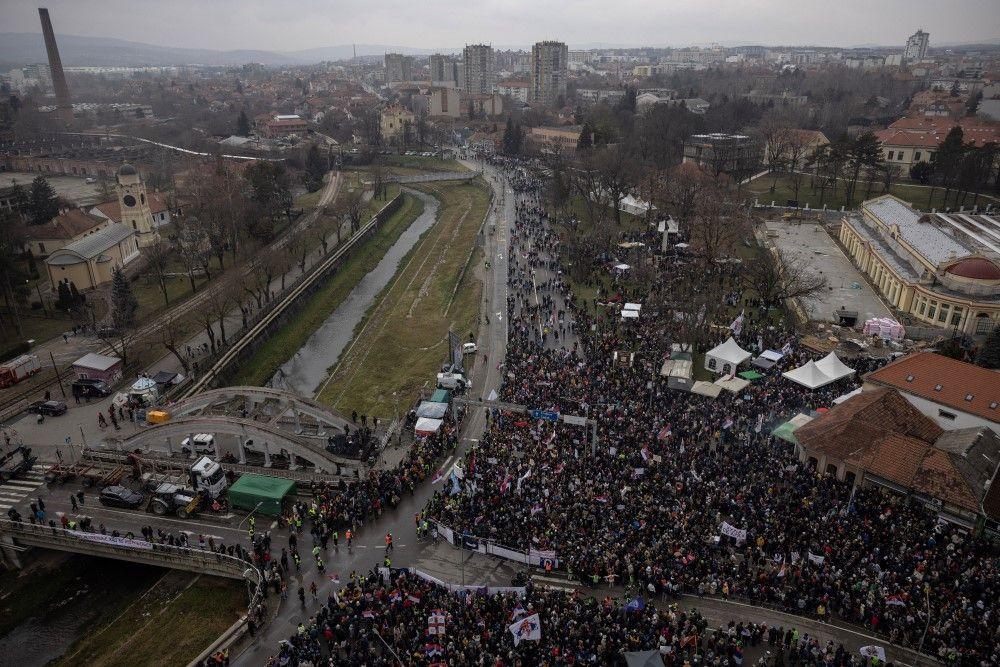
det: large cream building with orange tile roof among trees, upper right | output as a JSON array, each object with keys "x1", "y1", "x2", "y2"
[{"x1": 875, "y1": 116, "x2": 1000, "y2": 174}]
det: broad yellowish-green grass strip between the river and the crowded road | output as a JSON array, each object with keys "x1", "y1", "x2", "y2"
[{"x1": 319, "y1": 180, "x2": 490, "y2": 418}]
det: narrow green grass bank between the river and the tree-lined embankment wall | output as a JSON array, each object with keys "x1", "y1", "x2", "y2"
[{"x1": 231, "y1": 195, "x2": 424, "y2": 386}]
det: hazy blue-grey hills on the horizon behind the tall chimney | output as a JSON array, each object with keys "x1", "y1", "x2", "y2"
[{"x1": 0, "y1": 32, "x2": 454, "y2": 67}]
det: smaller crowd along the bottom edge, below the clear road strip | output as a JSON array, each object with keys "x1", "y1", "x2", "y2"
[{"x1": 269, "y1": 569, "x2": 876, "y2": 667}]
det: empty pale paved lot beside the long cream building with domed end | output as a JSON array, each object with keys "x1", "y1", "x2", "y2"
[{"x1": 765, "y1": 220, "x2": 892, "y2": 322}]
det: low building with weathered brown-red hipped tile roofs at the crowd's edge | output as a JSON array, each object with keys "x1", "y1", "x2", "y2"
[{"x1": 793, "y1": 383, "x2": 1000, "y2": 532}]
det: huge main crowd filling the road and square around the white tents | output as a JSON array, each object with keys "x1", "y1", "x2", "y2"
[{"x1": 418, "y1": 159, "x2": 1000, "y2": 665}]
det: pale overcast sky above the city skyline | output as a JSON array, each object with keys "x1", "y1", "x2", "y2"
[{"x1": 0, "y1": 0, "x2": 1000, "y2": 51}]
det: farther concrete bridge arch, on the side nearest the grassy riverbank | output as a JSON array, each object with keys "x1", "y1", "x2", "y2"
[{"x1": 168, "y1": 386, "x2": 351, "y2": 442}]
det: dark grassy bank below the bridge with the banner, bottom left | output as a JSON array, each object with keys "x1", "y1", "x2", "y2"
[{"x1": 53, "y1": 573, "x2": 246, "y2": 667}]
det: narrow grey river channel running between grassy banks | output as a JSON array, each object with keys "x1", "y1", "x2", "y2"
[{"x1": 268, "y1": 190, "x2": 438, "y2": 396}]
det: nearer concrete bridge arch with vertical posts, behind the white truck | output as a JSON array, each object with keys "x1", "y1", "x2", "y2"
[{"x1": 105, "y1": 416, "x2": 358, "y2": 473}]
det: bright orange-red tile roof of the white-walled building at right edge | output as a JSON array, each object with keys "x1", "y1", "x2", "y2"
[{"x1": 865, "y1": 352, "x2": 1000, "y2": 423}]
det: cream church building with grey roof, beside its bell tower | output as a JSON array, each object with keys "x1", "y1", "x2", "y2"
[{"x1": 45, "y1": 225, "x2": 139, "y2": 292}]
